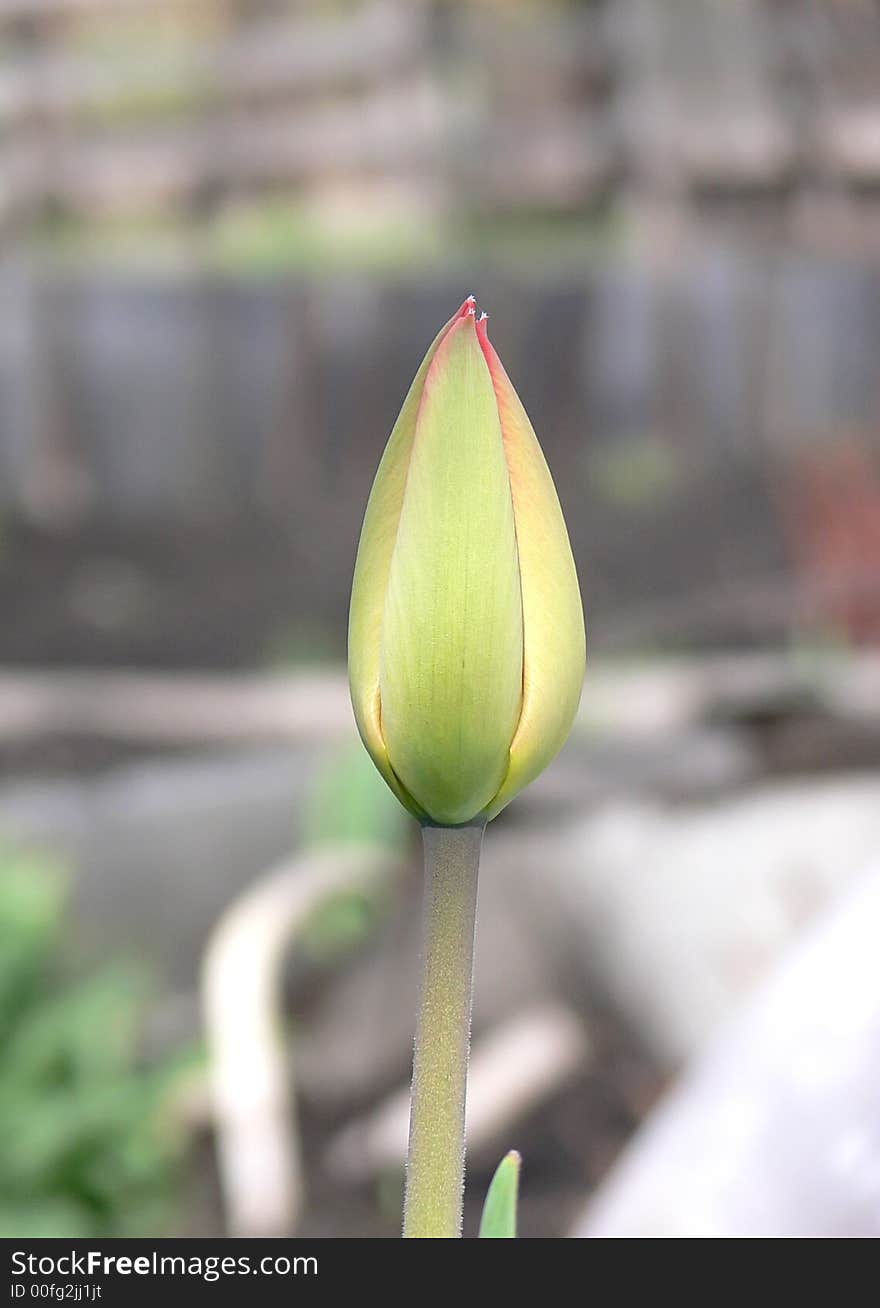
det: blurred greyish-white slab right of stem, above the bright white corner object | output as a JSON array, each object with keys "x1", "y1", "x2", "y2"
[{"x1": 536, "y1": 776, "x2": 880, "y2": 1066}]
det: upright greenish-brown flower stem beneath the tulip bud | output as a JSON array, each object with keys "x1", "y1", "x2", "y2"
[{"x1": 403, "y1": 823, "x2": 485, "y2": 1240}]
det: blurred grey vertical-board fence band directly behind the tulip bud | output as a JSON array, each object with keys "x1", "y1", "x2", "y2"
[{"x1": 0, "y1": 254, "x2": 880, "y2": 654}]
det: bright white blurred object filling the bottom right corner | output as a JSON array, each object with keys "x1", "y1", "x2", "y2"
[{"x1": 573, "y1": 866, "x2": 880, "y2": 1239}]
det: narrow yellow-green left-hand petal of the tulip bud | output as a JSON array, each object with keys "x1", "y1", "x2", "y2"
[{"x1": 348, "y1": 308, "x2": 467, "y2": 816}]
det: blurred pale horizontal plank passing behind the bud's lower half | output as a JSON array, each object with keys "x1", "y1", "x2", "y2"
[{"x1": 0, "y1": 654, "x2": 880, "y2": 746}]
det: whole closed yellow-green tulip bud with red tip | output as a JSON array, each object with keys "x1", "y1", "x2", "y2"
[{"x1": 348, "y1": 297, "x2": 584, "y2": 825}]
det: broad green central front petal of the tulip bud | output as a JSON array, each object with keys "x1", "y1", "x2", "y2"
[{"x1": 379, "y1": 313, "x2": 523, "y2": 824}]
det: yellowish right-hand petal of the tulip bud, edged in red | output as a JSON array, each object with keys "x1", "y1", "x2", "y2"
[{"x1": 480, "y1": 323, "x2": 586, "y2": 818}]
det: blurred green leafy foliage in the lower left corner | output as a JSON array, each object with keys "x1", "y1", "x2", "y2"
[{"x1": 0, "y1": 849, "x2": 190, "y2": 1239}]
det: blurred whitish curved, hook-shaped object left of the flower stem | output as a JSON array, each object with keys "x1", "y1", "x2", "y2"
[{"x1": 203, "y1": 846, "x2": 398, "y2": 1236}]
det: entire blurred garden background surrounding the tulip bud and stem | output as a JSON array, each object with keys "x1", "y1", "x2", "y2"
[{"x1": 0, "y1": 0, "x2": 880, "y2": 1237}]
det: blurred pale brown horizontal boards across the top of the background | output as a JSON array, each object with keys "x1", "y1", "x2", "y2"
[{"x1": 0, "y1": 0, "x2": 880, "y2": 241}]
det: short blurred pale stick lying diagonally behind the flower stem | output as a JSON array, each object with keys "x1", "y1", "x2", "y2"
[{"x1": 327, "y1": 1003, "x2": 590, "y2": 1182}]
